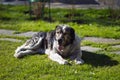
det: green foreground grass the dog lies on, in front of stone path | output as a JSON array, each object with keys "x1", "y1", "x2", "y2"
[{"x1": 0, "y1": 41, "x2": 120, "y2": 80}]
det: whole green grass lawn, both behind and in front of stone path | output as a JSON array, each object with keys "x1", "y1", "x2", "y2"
[{"x1": 0, "y1": 5, "x2": 120, "y2": 80}]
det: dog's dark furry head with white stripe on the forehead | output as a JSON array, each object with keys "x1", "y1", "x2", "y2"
[{"x1": 55, "y1": 25, "x2": 75, "y2": 48}]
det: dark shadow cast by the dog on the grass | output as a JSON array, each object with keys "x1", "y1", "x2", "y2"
[{"x1": 82, "y1": 51, "x2": 118, "y2": 67}]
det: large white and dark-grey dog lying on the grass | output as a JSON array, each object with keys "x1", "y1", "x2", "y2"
[{"x1": 14, "y1": 25, "x2": 84, "y2": 64}]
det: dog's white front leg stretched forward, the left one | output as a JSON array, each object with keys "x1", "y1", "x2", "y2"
[{"x1": 49, "y1": 53, "x2": 68, "y2": 64}]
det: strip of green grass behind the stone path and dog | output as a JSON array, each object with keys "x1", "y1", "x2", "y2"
[{"x1": 0, "y1": 5, "x2": 120, "y2": 39}]
